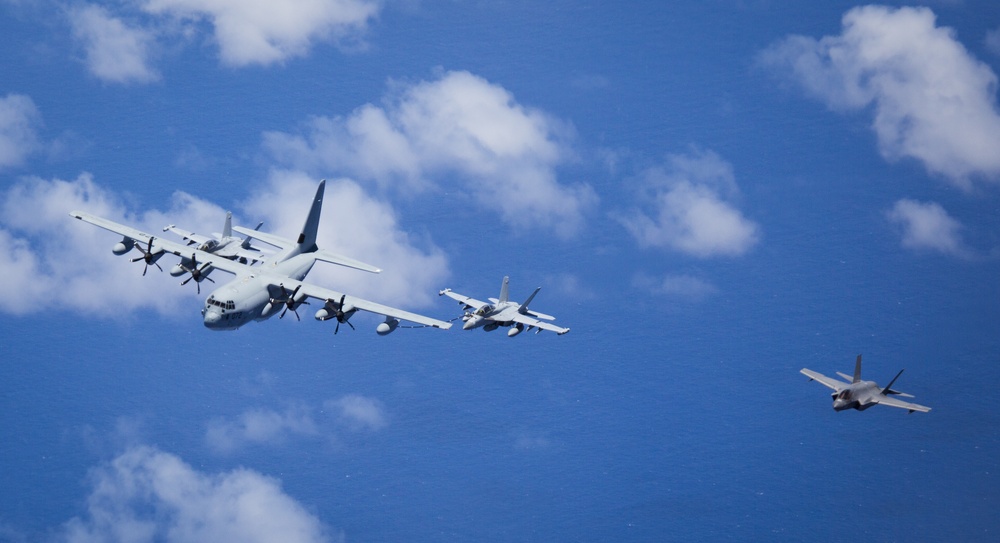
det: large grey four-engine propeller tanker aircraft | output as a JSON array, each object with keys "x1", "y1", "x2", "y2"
[{"x1": 70, "y1": 181, "x2": 451, "y2": 335}]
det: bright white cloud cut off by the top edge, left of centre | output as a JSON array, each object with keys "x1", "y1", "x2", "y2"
[{"x1": 142, "y1": 0, "x2": 380, "y2": 66}]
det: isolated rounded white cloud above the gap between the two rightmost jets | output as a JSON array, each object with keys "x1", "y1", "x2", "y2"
[{"x1": 614, "y1": 151, "x2": 759, "y2": 258}]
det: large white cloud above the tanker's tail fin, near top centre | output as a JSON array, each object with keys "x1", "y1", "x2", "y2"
[{"x1": 264, "y1": 71, "x2": 597, "y2": 237}]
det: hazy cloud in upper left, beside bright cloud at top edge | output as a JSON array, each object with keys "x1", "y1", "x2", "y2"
[{"x1": 69, "y1": 4, "x2": 160, "y2": 83}]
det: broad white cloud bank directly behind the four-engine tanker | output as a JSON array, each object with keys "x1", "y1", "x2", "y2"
[{"x1": 0, "y1": 174, "x2": 447, "y2": 316}]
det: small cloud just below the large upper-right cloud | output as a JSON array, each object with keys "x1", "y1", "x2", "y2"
[{"x1": 886, "y1": 199, "x2": 968, "y2": 257}]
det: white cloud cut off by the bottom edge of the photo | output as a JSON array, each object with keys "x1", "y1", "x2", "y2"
[{"x1": 61, "y1": 446, "x2": 332, "y2": 543}]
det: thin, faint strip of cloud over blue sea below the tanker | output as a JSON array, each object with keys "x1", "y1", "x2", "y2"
[{"x1": 205, "y1": 394, "x2": 387, "y2": 454}]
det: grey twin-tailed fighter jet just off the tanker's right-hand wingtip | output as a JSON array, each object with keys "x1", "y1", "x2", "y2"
[{"x1": 438, "y1": 277, "x2": 569, "y2": 337}]
